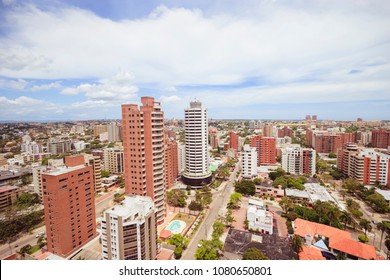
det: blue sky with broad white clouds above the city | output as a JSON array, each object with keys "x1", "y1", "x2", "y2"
[{"x1": 0, "y1": 0, "x2": 390, "y2": 121}]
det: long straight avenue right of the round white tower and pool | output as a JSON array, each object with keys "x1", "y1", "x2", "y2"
[{"x1": 181, "y1": 162, "x2": 239, "y2": 260}]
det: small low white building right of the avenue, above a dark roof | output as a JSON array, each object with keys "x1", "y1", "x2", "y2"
[{"x1": 247, "y1": 199, "x2": 273, "y2": 234}]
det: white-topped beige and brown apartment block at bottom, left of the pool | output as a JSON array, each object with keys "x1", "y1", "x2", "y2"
[{"x1": 101, "y1": 196, "x2": 157, "y2": 260}]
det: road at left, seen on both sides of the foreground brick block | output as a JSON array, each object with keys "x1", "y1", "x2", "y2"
[{"x1": 0, "y1": 188, "x2": 124, "y2": 259}]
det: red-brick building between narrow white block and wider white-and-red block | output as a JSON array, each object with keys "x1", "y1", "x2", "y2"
[{"x1": 250, "y1": 134, "x2": 276, "y2": 166}]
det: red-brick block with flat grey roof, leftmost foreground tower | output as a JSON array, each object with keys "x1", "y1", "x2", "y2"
[{"x1": 42, "y1": 155, "x2": 96, "y2": 257}]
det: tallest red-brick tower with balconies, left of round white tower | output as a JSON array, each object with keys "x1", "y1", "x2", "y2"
[{"x1": 122, "y1": 97, "x2": 165, "y2": 223}]
